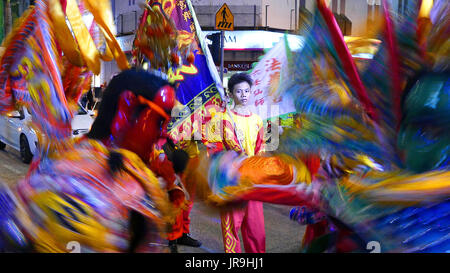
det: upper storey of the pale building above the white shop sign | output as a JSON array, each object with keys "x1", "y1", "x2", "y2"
[{"x1": 192, "y1": 0, "x2": 386, "y2": 36}]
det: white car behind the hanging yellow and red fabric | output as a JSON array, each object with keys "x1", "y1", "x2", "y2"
[{"x1": 0, "y1": 105, "x2": 94, "y2": 164}]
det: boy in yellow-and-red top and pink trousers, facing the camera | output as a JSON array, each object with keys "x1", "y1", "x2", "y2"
[{"x1": 207, "y1": 73, "x2": 266, "y2": 253}]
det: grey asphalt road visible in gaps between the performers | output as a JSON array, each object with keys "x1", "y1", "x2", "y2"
[{"x1": 0, "y1": 147, "x2": 305, "y2": 253}]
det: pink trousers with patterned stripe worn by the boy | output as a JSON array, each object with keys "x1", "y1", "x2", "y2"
[{"x1": 221, "y1": 201, "x2": 266, "y2": 253}]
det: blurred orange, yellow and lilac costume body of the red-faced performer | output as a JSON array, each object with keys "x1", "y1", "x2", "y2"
[{"x1": 13, "y1": 139, "x2": 170, "y2": 253}]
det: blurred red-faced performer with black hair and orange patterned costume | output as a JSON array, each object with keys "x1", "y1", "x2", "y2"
[{"x1": 0, "y1": 70, "x2": 179, "y2": 252}]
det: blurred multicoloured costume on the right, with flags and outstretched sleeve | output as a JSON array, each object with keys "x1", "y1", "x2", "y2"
[{"x1": 205, "y1": 0, "x2": 450, "y2": 252}]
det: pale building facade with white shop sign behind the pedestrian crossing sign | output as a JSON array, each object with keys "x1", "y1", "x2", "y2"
[{"x1": 187, "y1": 0, "x2": 413, "y2": 85}]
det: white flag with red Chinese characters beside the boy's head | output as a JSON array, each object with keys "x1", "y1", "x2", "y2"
[{"x1": 250, "y1": 35, "x2": 295, "y2": 120}]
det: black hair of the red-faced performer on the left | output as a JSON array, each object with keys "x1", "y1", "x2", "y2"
[{"x1": 87, "y1": 69, "x2": 169, "y2": 140}]
